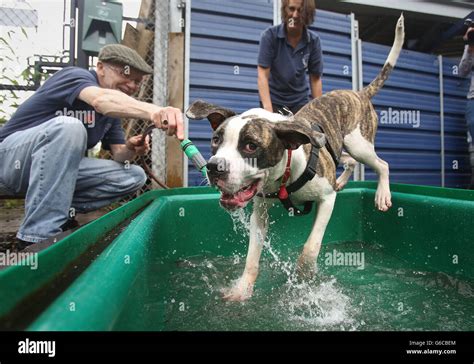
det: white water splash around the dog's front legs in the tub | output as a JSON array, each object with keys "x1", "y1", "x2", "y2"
[{"x1": 221, "y1": 205, "x2": 358, "y2": 330}]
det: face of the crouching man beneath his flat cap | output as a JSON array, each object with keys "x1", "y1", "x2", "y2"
[{"x1": 97, "y1": 62, "x2": 144, "y2": 96}]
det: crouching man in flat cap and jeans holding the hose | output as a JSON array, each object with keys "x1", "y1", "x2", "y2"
[{"x1": 0, "y1": 44, "x2": 184, "y2": 246}]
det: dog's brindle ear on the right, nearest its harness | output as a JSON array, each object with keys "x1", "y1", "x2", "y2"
[{"x1": 273, "y1": 121, "x2": 326, "y2": 149}]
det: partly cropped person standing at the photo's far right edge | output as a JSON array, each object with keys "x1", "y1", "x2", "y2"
[{"x1": 459, "y1": 27, "x2": 474, "y2": 189}]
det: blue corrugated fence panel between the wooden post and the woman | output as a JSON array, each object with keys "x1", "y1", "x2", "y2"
[{"x1": 188, "y1": 0, "x2": 273, "y2": 186}]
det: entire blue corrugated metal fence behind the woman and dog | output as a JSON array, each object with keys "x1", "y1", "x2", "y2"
[{"x1": 189, "y1": 0, "x2": 469, "y2": 187}]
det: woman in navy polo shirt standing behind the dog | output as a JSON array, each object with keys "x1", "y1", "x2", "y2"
[{"x1": 258, "y1": 0, "x2": 323, "y2": 114}]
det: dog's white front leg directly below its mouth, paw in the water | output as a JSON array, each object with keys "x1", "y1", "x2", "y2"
[{"x1": 224, "y1": 198, "x2": 268, "y2": 301}]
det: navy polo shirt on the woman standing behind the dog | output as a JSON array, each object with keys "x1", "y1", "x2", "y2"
[{"x1": 258, "y1": 23, "x2": 323, "y2": 106}]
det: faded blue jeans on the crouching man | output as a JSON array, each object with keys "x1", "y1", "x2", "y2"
[{"x1": 0, "y1": 116, "x2": 146, "y2": 243}]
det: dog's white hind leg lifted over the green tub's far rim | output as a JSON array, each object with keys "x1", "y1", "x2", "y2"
[{"x1": 344, "y1": 127, "x2": 392, "y2": 211}]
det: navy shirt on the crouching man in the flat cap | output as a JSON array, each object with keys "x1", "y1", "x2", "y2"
[{"x1": 0, "y1": 67, "x2": 125, "y2": 149}]
